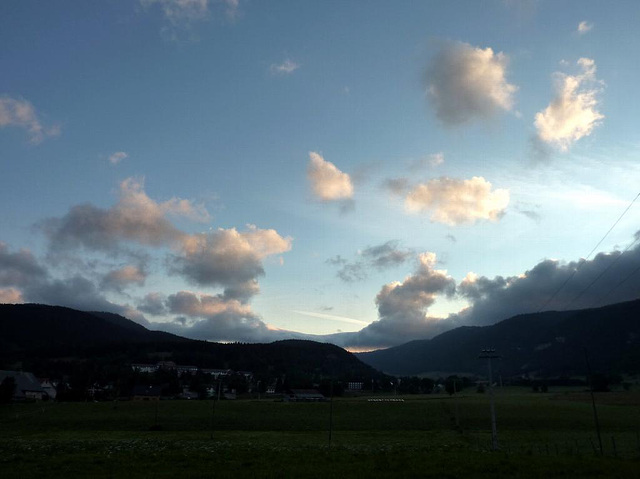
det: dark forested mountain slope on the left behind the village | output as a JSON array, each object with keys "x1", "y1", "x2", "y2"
[{"x1": 0, "y1": 304, "x2": 381, "y2": 379}]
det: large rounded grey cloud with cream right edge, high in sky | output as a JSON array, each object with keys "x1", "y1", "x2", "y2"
[{"x1": 426, "y1": 43, "x2": 517, "y2": 126}]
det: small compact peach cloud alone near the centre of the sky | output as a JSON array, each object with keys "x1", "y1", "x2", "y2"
[{"x1": 307, "y1": 151, "x2": 353, "y2": 201}]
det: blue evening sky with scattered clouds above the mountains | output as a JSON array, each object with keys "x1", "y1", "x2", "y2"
[{"x1": 0, "y1": 0, "x2": 640, "y2": 351}]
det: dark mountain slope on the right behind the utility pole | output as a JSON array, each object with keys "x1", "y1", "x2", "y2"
[{"x1": 357, "y1": 300, "x2": 640, "y2": 376}]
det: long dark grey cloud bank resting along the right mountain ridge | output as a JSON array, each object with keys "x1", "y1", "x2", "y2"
[{"x1": 456, "y1": 238, "x2": 640, "y2": 326}]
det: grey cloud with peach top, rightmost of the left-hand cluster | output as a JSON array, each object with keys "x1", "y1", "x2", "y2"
[{"x1": 170, "y1": 225, "x2": 293, "y2": 299}]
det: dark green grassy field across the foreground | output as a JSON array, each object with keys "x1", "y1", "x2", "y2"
[{"x1": 0, "y1": 389, "x2": 640, "y2": 478}]
